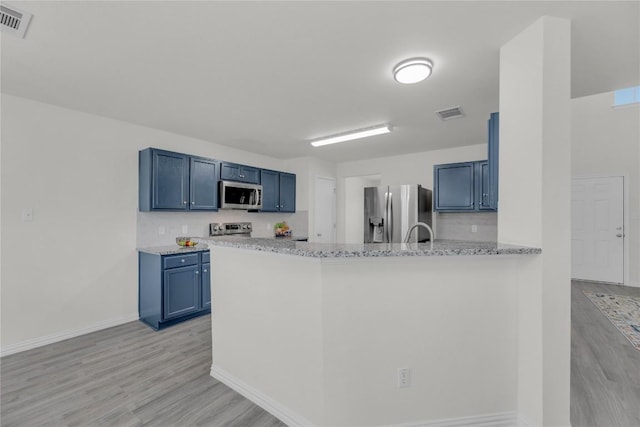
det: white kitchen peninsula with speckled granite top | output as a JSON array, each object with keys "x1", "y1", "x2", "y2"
[{"x1": 203, "y1": 237, "x2": 541, "y2": 426}]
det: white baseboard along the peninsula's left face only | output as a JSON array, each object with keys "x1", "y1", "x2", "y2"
[{"x1": 211, "y1": 364, "x2": 314, "y2": 427}]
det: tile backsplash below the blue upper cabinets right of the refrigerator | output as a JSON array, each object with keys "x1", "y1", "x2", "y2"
[{"x1": 434, "y1": 212, "x2": 498, "y2": 242}]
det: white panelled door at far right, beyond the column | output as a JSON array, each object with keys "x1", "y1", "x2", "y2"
[{"x1": 571, "y1": 176, "x2": 624, "y2": 283}]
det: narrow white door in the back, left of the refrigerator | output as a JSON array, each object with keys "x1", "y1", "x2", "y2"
[{"x1": 309, "y1": 176, "x2": 336, "y2": 243}]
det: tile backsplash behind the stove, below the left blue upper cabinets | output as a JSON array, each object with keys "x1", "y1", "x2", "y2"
[{"x1": 136, "y1": 210, "x2": 309, "y2": 248}]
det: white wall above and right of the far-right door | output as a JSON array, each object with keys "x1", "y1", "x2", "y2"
[{"x1": 571, "y1": 92, "x2": 640, "y2": 286}]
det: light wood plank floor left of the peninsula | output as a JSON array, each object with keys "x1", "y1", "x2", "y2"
[{"x1": 0, "y1": 316, "x2": 285, "y2": 427}]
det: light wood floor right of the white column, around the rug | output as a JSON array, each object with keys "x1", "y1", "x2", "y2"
[{"x1": 571, "y1": 281, "x2": 640, "y2": 427}]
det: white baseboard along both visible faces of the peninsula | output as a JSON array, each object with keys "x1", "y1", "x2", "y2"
[{"x1": 211, "y1": 364, "x2": 518, "y2": 427}]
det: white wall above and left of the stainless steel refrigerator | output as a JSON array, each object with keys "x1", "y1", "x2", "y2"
[{"x1": 336, "y1": 145, "x2": 488, "y2": 242}]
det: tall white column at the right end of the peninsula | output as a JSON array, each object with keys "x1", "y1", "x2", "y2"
[{"x1": 498, "y1": 17, "x2": 571, "y2": 426}]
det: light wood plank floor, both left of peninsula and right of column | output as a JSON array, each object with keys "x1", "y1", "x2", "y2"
[{"x1": 0, "y1": 282, "x2": 640, "y2": 427}]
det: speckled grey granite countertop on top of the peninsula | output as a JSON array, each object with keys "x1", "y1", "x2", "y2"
[{"x1": 199, "y1": 236, "x2": 542, "y2": 258}]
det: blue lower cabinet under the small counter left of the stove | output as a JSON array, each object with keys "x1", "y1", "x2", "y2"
[{"x1": 138, "y1": 251, "x2": 211, "y2": 330}]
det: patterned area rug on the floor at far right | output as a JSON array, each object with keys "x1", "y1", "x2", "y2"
[{"x1": 583, "y1": 291, "x2": 640, "y2": 351}]
